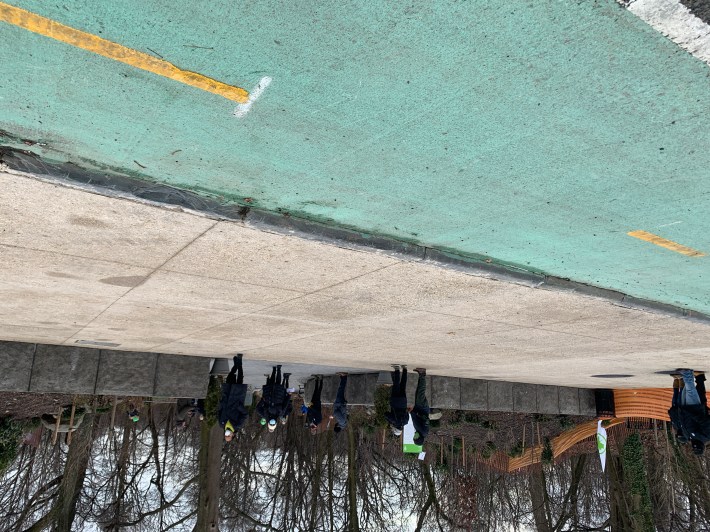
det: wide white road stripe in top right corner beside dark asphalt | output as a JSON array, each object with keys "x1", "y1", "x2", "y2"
[{"x1": 622, "y1": 0, "x2": 710, "y2": 65}]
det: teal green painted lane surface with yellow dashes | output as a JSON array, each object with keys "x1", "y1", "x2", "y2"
[{"x1": 0, "y1": 0, "x2": 710, "y2": 313}]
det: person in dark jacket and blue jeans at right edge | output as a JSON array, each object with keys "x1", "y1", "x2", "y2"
[{"x1": 668, "y1": 369, "x2": 710, "y2": 455}]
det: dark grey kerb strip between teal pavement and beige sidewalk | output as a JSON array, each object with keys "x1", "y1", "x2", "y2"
[{"x1": 0, "y1": 146, "x2": 710, "y2": 325}]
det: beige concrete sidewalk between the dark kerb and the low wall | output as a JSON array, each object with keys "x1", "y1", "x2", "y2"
[{"x1": 0, "y1": 173, "x2": 710, "y2": 388}]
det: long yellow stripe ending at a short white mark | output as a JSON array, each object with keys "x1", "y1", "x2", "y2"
[{"x1": 0, "y1": 2, "x2": 249, "y2": 103}]
